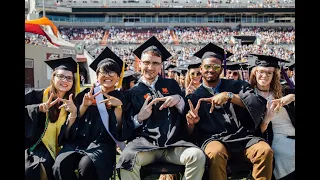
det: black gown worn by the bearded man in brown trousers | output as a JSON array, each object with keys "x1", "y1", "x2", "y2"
[{"x1": 185, "y1": 79, "x2": 266, "y2": 157}]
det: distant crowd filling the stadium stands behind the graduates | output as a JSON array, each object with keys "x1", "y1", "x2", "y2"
[{"x1": 26, "y1": 27, "x2": 295, "y2": 61}]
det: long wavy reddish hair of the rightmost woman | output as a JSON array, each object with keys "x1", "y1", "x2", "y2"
[{"x1": 249, "y1": 67, "x2": 282, "y2": 99}]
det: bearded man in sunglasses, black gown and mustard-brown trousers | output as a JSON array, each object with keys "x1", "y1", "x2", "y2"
[{"x1": 186, "y1": 43, "x2": 273, "y2": 180}]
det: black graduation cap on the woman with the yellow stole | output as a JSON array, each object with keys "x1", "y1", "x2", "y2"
[{"x1": 44, "y1": 57, "x2": 78, "y2": 73}]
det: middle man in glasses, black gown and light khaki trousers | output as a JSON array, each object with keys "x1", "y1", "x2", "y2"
[{"x1": 117, "y1": 36, "x2": 206, "y2": 180}]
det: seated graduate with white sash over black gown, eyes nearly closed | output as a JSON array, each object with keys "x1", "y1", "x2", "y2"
[{"x1": 53, "y1": 47, "x2": 128, "y2": 180}]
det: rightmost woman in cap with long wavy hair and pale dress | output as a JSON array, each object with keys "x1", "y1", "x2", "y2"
[{"x1": 250, "y1": 55, "x2": 295, "y2": 180}]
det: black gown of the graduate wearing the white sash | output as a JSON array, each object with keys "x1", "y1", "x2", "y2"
[{"x1": 56, "y1": 88, "x2": 130, "y2": 180}]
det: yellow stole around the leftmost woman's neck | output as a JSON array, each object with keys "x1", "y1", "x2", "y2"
[{"x1": 42, "y1": 88, "x2": 67, "y2": 159}]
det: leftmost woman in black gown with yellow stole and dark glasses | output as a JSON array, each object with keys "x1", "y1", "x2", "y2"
[{"x1": 25, "y1": 57, "x2": 77, "y2": 180}]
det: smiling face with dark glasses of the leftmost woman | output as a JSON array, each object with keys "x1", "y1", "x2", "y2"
[{"x1": 52, "y1": 69, "x2": 74, "y2": 92}]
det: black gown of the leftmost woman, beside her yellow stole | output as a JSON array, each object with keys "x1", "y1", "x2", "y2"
[{"x1": 24, "y1": 89, "x2": 54, "y2": 180}]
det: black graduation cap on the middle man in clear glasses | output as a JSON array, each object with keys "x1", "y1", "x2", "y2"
[{"x1": 133, "y1": 36, "x2": 172, "y2": 61}]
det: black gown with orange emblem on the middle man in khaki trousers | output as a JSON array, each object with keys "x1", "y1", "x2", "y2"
[{"x1": 117, "y1": 77, "x2": 197, "y2": 170}]
